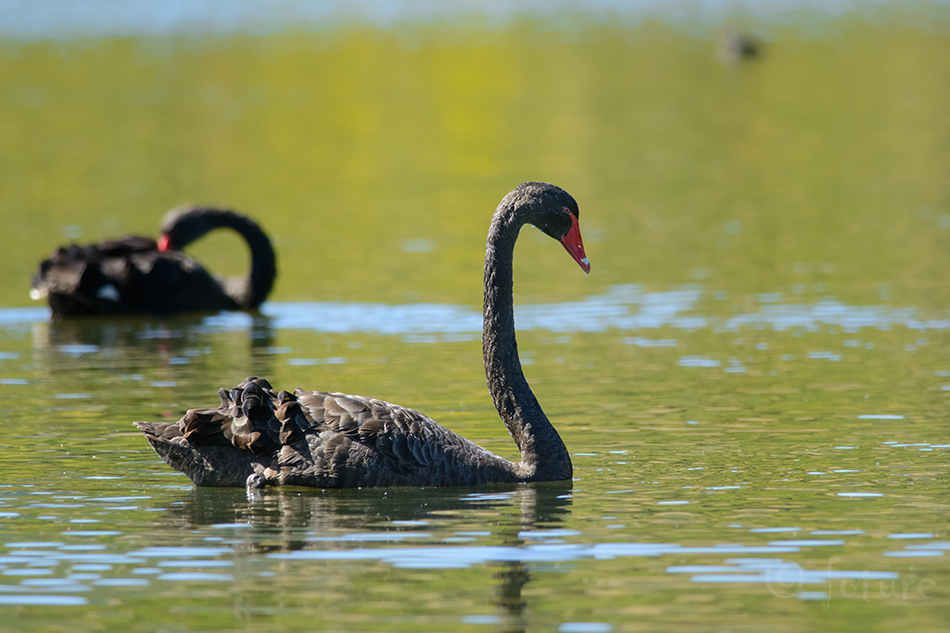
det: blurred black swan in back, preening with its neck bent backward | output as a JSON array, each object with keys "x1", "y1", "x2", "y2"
[{"x1": 30, "y1": 206, "x2": 277, "y2": 316}]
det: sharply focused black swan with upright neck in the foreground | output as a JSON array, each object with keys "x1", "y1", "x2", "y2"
[{"x1": 135, "y1": 182, "x2": 590, "y2": 488}]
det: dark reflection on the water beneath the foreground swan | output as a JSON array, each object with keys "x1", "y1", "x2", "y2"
[{"x1": 163, "y1": 482, "x2": 572, "y2": 632}]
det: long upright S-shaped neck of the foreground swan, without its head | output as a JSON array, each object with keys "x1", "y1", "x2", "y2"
[{"x1": 482, "y1": 201, "x2": 573, "y2": 481}]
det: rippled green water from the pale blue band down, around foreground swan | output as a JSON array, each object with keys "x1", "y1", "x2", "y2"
[{"x1": 0, "y1": 286, "x2": 950, "y2": 631}]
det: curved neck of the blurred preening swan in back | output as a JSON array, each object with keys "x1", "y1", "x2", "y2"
[{"x1": 200, "y1": 211, "x2": 277, "y2": 308}]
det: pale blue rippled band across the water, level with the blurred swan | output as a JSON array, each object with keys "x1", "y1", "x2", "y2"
[{"x1": 7, "y1": 284, "x2": 950, "y2": 336}]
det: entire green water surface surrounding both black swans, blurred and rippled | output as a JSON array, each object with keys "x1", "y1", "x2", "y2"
[{"x1": 0, "y1": 9, "x2": 950, "y2": 633}]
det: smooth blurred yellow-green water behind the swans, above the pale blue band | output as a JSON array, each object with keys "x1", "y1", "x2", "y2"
[{"x1": 0, "y1": 4, "x2": 950, "y2": 310}]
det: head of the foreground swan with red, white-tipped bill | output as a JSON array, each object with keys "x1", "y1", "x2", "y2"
[{"x1": 503, "y1": 182, "x2": 590, "y2": 273}]
